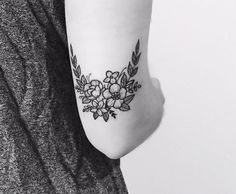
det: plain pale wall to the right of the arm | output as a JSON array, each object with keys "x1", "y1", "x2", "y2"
[{"x1": 121, "y1": 0, "x2": 236, "y2": 194}]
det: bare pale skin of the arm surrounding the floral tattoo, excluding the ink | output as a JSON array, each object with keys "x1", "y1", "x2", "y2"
[{"x1": 65, "y1": 0, "x2": 164, "y2": 159}]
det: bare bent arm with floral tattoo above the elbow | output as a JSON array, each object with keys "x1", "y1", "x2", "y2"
[{"x1": 66, "y1": 0, "x2": 163, "y2": 159}]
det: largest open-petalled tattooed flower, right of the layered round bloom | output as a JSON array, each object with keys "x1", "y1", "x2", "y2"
[{"x1": 103, "y1": 84, "x2": 126, "y2": 109}]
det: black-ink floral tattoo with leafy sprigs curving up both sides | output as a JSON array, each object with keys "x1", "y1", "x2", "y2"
[{"x1": 70, "y1": 40, "x2": 141, "y2": 122}]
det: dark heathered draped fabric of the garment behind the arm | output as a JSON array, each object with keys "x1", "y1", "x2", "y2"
[{"x1": 0, "y1": 0, "x2": 128, "y2": 194}]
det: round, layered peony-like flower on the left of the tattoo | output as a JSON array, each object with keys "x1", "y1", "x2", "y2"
[{"x1": 84, "y1": 80, "x2": 103, "y2": 101}]
